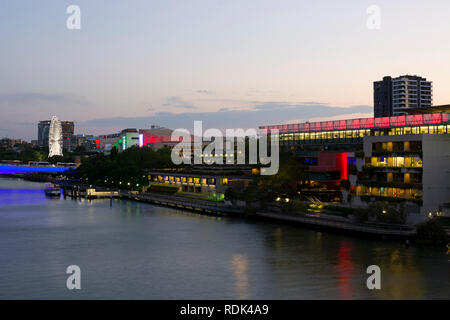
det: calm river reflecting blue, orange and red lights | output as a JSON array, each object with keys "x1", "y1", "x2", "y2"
[{"x1": 0, "y1": 178, "x2": 450, "y2": 299}]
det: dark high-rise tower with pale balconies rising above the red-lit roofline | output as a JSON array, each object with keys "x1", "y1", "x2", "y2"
[{"x1": 373, "y1": 75, "x2": 433, "y2": 117}]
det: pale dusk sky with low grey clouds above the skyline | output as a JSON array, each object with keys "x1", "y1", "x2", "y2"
[{"x1": 0, "y1": 0, "x2": 450, "y2": 140}]
